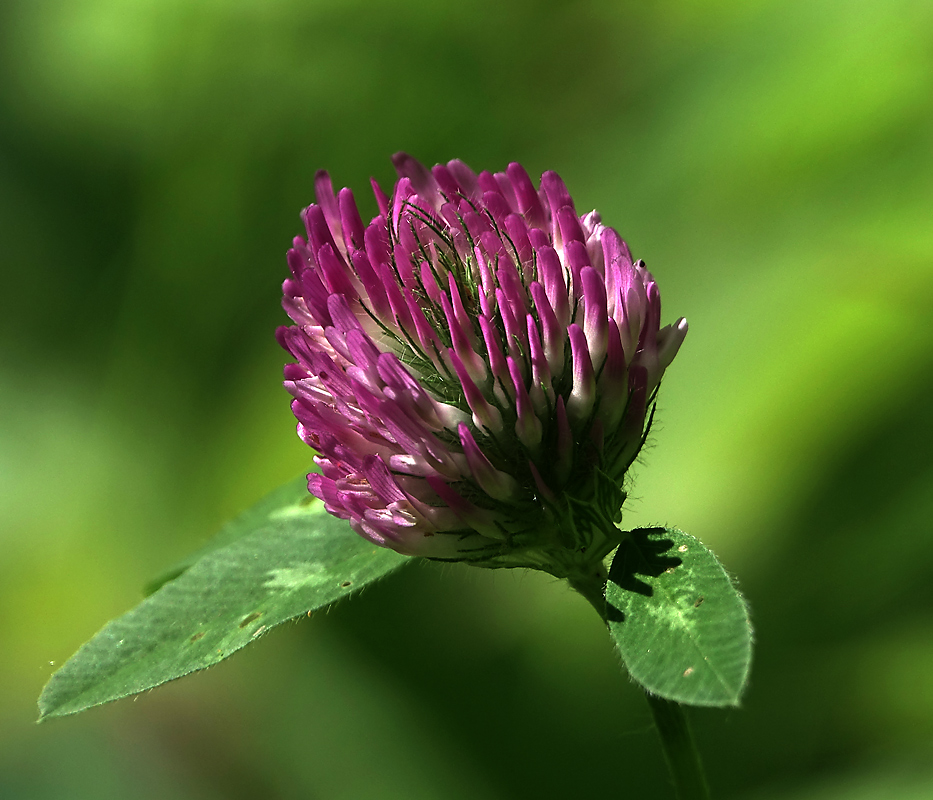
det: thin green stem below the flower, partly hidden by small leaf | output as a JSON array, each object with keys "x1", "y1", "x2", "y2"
[{"x1": 568, "y1": 570, "x2": 709, "y2": 800}]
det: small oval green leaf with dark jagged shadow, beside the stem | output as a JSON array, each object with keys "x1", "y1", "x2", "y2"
[{"x1": 606, "y1": 528, "x2": 752, "y2": 706}]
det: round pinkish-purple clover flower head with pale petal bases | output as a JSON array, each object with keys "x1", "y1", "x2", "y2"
[{"x1": 278, "y1": 153, "x2": 687, "y2": 577}]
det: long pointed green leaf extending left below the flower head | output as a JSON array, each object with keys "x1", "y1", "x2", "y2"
[{"x1": 39, "y1": 480, "x2": 410, "y2": 720}]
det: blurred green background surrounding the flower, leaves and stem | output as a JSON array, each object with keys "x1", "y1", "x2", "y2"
[{"x1": 0, "y1": 0, "x2": 933, "y2": 800}]
